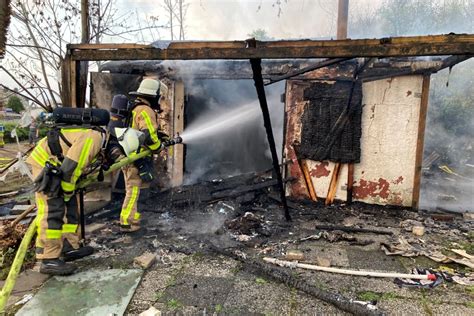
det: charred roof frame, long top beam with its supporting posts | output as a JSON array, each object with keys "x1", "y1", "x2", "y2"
[{"x1": 62, "y1": 34, "x2": 474, "y2": 215}]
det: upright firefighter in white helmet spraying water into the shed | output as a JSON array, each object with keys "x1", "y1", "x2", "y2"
[{"x1": 120, "y1": 79, "x2": 161, "y2": 232}]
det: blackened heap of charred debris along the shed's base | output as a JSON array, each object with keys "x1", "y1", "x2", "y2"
[{"x1": 92, "y1": 169, "x2": 474, "y2": 255}]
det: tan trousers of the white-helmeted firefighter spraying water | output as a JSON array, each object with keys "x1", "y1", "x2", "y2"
[{"x1": 120, "y1": 164, "x2": 142, "y2": 226}]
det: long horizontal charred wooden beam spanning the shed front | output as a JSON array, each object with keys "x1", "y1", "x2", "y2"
[{"x1": 68, "y1": 34, "x2": 474, "y2": 60}]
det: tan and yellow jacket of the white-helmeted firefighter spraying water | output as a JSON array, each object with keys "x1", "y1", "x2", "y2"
[{"x1": 131, "y1": 98, "x2": 161, "y2": 150}]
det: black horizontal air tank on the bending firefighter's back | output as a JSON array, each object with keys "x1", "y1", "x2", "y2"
[{"x1": 49, "y1": 107, "x2": 110, "y2": 126}]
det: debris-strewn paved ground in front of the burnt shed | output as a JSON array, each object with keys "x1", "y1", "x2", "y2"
[{"x1": 0, "y1": 174, "x2": 474, "y2": 314}]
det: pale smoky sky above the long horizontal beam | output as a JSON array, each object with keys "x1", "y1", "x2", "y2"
[{"x1": 113, "y1": 0, "x2": 380, "y2": 40}]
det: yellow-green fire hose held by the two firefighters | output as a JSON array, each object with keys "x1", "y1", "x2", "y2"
[{"x1": 0, "y1": 136, "x2": 183, "y2": 313}]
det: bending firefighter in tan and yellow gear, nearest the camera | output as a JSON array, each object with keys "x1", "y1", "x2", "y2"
[{"x1": 27, "y1": 128, "x2": 105, "y2": 275}]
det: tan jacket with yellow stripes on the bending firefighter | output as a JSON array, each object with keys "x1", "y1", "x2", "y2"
[{"x1": 27, "y1": 128, "x2": 105, "y2": 192}]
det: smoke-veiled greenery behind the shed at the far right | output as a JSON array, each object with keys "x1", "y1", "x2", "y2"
[{"x1": 348, "y1": 0, "x2": 474, "y2": 167}]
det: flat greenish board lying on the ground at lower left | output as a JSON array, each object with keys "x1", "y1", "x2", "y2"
[{"x1": 16, "y1": 269, "x2": 143, "y2": 316}]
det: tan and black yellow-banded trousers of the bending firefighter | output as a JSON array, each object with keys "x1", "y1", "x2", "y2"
[{"x1": 33, "y1": 168, "x2": 80, "y2": 259}]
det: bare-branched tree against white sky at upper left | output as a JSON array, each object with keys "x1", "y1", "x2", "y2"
[{"x1": 0, "y1": 0, "x2": 168, "y2": 110}]
